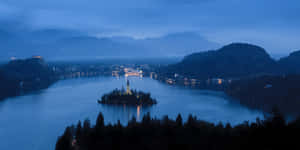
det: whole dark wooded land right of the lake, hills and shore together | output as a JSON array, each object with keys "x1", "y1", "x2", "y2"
[{"x1": 158, "y1": 43, "x2": 300, "y2": 115}]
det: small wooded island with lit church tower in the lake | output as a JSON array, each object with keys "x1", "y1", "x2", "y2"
[{"x1": 98, "y1": 80, "x2": 157, "y2": 106}]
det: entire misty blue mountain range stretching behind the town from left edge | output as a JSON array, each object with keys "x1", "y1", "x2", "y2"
[{"x1": 0, "y1": 29, "x2": 219, "y2": 59}]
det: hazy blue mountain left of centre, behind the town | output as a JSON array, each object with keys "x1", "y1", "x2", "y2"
[{"x1": 45, "y1": 36, "x2": 149, "y2": 58}]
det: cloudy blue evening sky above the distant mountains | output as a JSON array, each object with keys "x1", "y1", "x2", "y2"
[{"x1": 0, "y1": 0, "x2": 300, "y2": 54}]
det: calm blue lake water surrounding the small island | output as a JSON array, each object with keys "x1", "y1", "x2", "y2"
[{"x1": 0, "y1": 77, "x2": 263, "y2": 150}]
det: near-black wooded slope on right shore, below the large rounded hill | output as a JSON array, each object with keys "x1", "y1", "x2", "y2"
[{"x1": 226, "y1": 75, "x2": 300, "y2": 116}]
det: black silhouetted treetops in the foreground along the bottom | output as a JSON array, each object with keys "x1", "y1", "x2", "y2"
[{"x1": 56, "y1": 109, "x2": 300, "y2": 150}]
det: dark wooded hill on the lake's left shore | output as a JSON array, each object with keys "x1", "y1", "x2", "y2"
[{"x1": 0, "y1": 58, "x2": 57, "y2": 100}]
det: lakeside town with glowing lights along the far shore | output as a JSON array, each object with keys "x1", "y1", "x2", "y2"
[{"x1": 50, "y1": 56, "x2": 233, "y2": 90}]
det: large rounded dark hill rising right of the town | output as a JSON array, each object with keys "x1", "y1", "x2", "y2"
[{"x1": 162, "y1": 43, "x2": 277, "y2": 79}]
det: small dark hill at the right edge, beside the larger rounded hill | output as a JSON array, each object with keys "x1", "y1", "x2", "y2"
[{"x1": 278, "y1": 51, "x2": 300, "y2": 74}]
